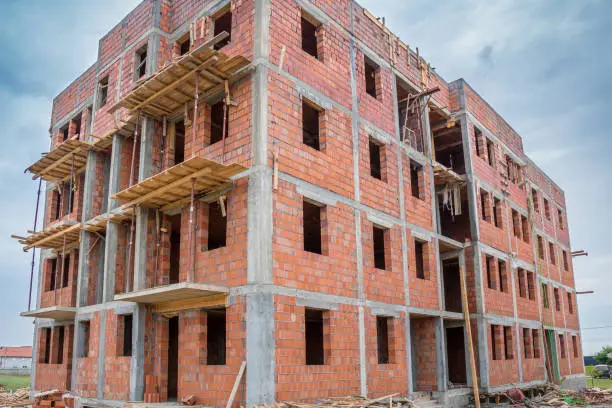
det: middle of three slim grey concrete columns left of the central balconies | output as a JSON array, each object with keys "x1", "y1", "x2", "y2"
[{"x1": 102, "y1": 134, "x2": 123, "y2": 302}]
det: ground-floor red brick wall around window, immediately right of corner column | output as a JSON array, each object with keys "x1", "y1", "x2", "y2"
[{"x1": 274, "y1": 295, "x2": 360, "y2": 401}]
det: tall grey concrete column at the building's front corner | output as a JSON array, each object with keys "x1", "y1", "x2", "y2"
[{"x1": 246, "y1": 0, "x2": 276, "y2": 408}]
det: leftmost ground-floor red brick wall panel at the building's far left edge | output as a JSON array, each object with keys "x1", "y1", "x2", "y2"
[{"x1": 34, "y1": 325, "x2": 74, "y2": 390}]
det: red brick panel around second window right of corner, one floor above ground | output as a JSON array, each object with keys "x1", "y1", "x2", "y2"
[{"x1": 361, "y1": 217, "x2": 406, "y2": 305}]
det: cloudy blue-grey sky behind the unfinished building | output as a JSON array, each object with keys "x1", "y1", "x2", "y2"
[{"x1": 0, "y1": 0, "x2": 612, "y2": 354}]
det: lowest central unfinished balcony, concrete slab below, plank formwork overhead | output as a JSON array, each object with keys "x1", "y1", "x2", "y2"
[{"x1": 110, "y1": 157, "x2": 246, "y2": 313}]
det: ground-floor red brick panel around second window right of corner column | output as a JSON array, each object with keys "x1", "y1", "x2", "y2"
[{"x1": 365, "y1": 309, "x2": 409, "y2": 398}]
